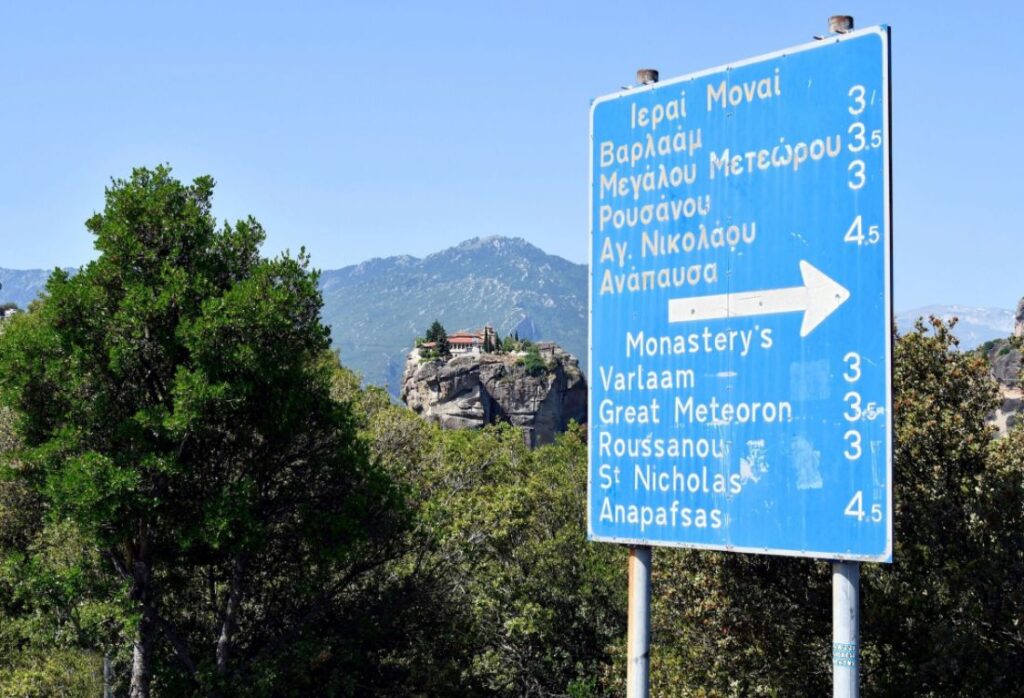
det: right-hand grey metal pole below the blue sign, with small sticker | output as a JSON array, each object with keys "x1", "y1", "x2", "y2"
[{"x1": 833, "y1": 561, "x2": 860, "y2": 698}]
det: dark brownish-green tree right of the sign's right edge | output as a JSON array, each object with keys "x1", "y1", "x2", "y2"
[{"x1": 862, "y1": 319, "x2": 1024, "y2": 696}]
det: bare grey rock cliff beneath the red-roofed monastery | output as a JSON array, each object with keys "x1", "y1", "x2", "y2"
[{"x1": 401, "y1": 343, "x2": 587, "y2": 447}]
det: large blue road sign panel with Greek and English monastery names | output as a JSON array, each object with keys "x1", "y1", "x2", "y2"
[{"x1": 588, "y1": 28, "x2": 893, "y2": 562}]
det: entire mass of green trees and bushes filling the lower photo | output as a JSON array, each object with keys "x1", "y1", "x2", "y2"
[{"x1": 0, "y1": 168, "x2": 1024, "y2": 698}]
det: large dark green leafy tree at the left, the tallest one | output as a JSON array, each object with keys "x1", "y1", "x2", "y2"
[{"x1": 0, "y1": 167, "x2": 402, "y2": 698}]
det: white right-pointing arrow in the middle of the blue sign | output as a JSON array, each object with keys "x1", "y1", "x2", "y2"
[{"x1": 669, "y1": 260, "x2": 850, "y2": 337}]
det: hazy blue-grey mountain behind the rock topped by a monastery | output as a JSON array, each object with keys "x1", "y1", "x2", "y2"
[{"x1": 321, "y1": 237, "x2": 587, "y2": 395}]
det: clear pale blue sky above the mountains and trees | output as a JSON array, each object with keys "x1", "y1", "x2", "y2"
[{"x1": 0, "y1": 0, "x2": 1024, "y2": 309}]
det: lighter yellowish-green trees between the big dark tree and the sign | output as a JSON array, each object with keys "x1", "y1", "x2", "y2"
[{"x1": 337, "y1": 382, "x2": 626, "y2": 697}]
